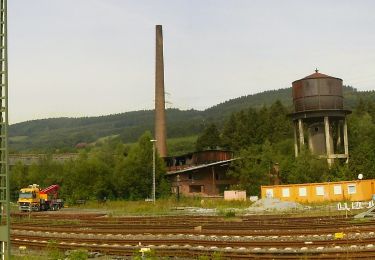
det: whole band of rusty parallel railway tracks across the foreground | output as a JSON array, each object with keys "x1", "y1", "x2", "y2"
[{"x1": 11, "y1": 213, "x2": 375, "y2": 259}]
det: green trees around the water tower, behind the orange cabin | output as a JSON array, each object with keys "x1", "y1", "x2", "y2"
[{"x1": 196, "y1": 99, "x2": 375, "y2": 195}]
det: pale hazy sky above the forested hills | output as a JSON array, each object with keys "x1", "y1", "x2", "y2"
[{"x1": 8, "y1": 0, "x2": 375, "y2": 124}]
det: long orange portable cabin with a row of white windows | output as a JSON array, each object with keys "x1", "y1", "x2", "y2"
[{"x1": 261, "y1": 179, "x2": 375, "y2": 202}]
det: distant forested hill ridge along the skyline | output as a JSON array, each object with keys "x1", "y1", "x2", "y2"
[{"x1": 9, "y1": 87, "x2": 375, "y2": 152}]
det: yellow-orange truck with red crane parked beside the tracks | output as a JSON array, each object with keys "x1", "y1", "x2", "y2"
[{"x1": 18, "y1": 184, "x2": 64, "y2": 211}]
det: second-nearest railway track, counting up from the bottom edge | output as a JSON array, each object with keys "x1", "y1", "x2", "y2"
[{"x1": 12, "y1": 232, "x2": 375, "y2": 249}]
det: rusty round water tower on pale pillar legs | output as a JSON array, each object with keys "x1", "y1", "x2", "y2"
[{"x1": 291, "y1": 70, "x2": 351, "y2": 165}]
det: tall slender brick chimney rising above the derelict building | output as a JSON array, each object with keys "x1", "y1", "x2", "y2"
[{"x1": 155, "y1": 25, "x2": 167, "y2": 157}]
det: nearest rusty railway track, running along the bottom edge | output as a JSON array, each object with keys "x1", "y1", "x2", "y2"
[{"x1": 12, "y1": 237, "x2": 375, "y2": 259}]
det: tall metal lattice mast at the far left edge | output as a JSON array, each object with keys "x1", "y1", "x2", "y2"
[{"x1": 0, "y1": 0, "x2": 10, "y2": 260}]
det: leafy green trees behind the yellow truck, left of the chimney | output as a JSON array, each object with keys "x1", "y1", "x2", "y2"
[{"x1": 11, "y1": 132, "x2": 170, "y2": 202}]
